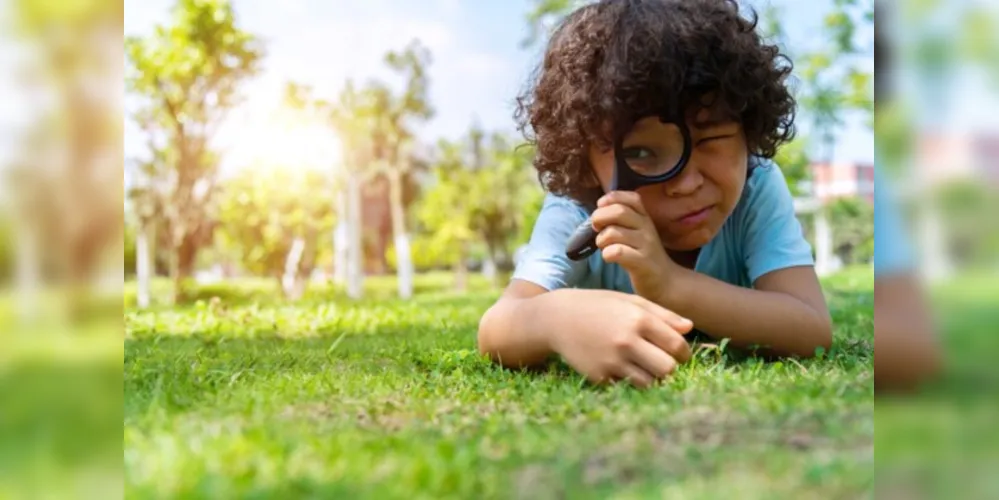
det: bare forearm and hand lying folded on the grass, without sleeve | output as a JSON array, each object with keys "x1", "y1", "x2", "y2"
[{"x1": 479, "y1": 280, "x2": 693, "y2": 387}]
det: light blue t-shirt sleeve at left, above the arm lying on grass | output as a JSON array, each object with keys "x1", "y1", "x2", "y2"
[{"x1": 512, "y1": 194, "x2": 587, "y2": 291}]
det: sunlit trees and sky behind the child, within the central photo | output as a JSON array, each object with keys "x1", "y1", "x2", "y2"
[{"x1": 111, "y1": 0, "x2": 875, "y2": 307}]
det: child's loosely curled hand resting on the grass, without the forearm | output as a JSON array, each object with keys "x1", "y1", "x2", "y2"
[{"x1": 545, "y1": 289, "x2": 693, "y2": 387}]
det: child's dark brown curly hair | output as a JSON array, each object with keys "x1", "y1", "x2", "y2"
[{"x1": 514, "y1": 0, "x2": 796, "y2": 202}]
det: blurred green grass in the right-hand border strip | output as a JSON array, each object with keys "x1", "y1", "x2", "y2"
[{"x1": 875, "y1": 272, "x2": 999, "y2": 498}]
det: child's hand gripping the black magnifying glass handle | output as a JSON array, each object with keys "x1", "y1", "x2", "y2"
[{"x1": 591, "y1": 191, "x2": 676, "y2": 302}]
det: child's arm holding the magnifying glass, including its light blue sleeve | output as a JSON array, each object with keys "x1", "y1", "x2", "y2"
[{"x1": 593, "y1": 166, "x2": 832, "y2": 356}]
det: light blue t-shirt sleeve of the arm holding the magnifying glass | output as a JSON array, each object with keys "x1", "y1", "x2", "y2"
[{"x1": 743, "y1": 161, "x2": 815, "y2": 283}]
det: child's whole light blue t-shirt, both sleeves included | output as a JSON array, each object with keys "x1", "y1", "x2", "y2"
[{"x1": 513, "y1": 157, "x2": 814, "y2": 293}]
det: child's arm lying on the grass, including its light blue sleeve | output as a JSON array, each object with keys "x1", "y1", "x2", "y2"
[{"x1": 478, "y1": 192, "x2": 692, "y2": 386}]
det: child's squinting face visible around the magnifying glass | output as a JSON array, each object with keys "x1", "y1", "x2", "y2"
[{"x1": 590, "y1": 109, "x2": 748, "y2": 251}]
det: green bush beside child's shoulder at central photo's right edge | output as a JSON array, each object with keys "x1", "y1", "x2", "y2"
[{"x1": 827, "y1": 198, "x2": 874, "y2": 264}]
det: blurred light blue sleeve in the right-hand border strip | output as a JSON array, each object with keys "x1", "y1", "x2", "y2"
[{"x1": 874, "y1": 169, "x2": 914, "y2": 277}]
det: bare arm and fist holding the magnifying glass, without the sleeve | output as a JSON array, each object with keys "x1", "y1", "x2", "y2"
[{"x1": 593, "y1": 192, "x2": 832, "y2": 357}]
